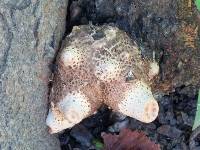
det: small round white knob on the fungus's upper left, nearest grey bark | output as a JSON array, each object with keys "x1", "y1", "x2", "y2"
[{"x1": 61, "y1": 46, "x2": 81, "y2": 67}]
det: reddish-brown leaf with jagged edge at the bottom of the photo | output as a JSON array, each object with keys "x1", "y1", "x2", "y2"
[{"x1": 102, "y1": 129, "x2": 160, "y2": 150}]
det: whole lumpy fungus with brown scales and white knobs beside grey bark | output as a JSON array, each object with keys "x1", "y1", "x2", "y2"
[{"x1": 46, "y1": 25, "x2": 159, "y2": 133}]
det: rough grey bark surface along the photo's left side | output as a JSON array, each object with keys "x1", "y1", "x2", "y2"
[{"x1": 0, "y1": 0, "x2": 68, "y2": 150}]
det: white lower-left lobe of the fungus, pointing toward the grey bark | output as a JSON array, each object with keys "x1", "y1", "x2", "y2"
[{"x1": 46, "y1": 92, "x2": 91, "y2": 133}]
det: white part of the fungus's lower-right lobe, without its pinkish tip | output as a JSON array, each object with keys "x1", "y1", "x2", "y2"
[{"x1": 118, "y1": 82, "x2": 157, "y2": 122}]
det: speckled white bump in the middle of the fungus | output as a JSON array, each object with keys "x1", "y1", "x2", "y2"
[{"x1": 95, "y1": 60, "x2": 120, "y2": 81}]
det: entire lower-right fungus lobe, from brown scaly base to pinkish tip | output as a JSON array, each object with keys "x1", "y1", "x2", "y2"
[{"x1": 105, "y1": 80, "x2": 159, "y2": 123}]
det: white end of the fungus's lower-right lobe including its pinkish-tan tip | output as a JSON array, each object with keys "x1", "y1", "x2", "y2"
[{"x1": 118, "y1": 81, "x2": 159, "y2": 123}]
